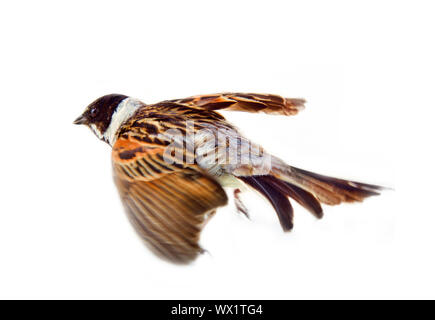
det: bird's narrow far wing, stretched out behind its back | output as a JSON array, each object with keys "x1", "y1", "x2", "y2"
[{"x1": 170, "y1": 93, "x2": 305, "y2": 116}]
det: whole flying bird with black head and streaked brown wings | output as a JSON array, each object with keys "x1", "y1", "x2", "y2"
[{"x1": 74, "y1": 93, "x2": 383, "y2": 264}]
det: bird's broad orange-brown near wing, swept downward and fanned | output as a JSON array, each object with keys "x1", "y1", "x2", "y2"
[{"x1": 112, "y1": 137, "x2": 227, "y2": 263}]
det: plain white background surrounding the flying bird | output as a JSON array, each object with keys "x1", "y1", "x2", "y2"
[{"x1": 0, "y1": 1, "x2": 435, "y2": 299}]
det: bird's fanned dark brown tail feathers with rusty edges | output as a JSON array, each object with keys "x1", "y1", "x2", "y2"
[{"x1": 238, "y1": 166, "x2": 383, "y2": 231}]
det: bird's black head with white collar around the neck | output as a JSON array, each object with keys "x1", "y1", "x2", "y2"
[{"x1": 74, "y1": 94, "x2": 142, "y2": 145}]
